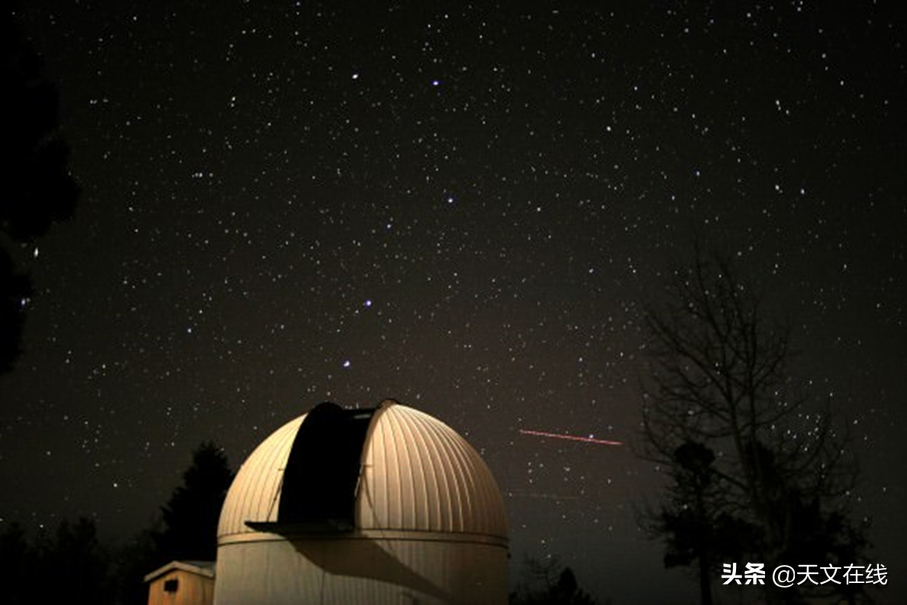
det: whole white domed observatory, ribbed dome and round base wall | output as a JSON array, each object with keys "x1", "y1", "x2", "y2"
[{"x1": 214, "y1": 400, "x2": 508, "y2": 605}]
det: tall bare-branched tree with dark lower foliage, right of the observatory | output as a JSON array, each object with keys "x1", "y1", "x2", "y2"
[{"x1": 640, "y1": 247, "x2": 866, "y2": 603}]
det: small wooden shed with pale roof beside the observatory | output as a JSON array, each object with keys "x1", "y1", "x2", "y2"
[{"x1": 145, "y1": 561, "x2": 214, "y2": 605}]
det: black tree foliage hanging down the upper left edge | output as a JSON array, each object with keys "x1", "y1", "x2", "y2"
[{"x1": 0, "y1": 6, "x2": 79, "y2": 373}]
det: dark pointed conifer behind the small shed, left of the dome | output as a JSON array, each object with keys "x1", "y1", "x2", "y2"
[{"x1": 157, "y1": 442, "x2": 233, "y2": 563}]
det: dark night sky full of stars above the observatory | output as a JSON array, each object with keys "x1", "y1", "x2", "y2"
[{"x1": 0, "y1": 0, "x2": 907, "y2": 603}]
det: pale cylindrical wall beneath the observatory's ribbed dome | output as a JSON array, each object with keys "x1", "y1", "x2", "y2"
[{"x1": 214, "y1": 532, "x2": 508, "y2": 605}]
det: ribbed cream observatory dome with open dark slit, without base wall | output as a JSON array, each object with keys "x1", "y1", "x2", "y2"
[{"x1": 218, "y1": 400, "x2": 507, "y2": 540}]
